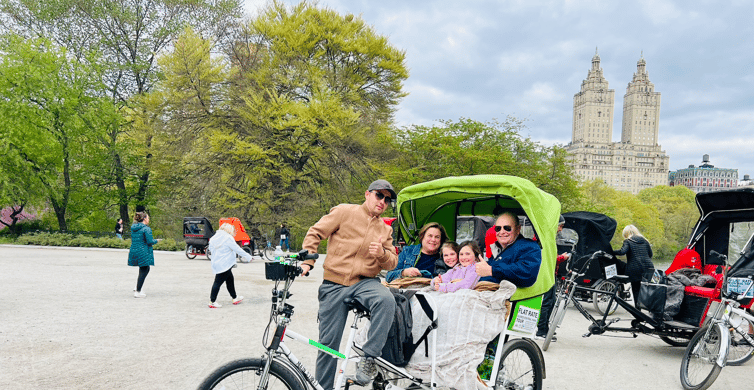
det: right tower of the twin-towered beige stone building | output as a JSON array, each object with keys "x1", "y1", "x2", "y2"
[{"x1": 621, "y1": 53, "x2": 660, "y2": 146}]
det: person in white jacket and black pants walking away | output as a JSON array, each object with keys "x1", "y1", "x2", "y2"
[{"x1": 209, "y1": 223, "x2": 251, "y2": 309}]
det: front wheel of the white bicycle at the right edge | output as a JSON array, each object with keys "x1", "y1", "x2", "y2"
[{"x1": 681, "y1": 324, "x2": 722, "y2": 390}]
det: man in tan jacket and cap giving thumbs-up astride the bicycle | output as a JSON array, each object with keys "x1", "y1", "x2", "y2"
[{"x1": 301, "y1": 180, "x2": 398, "y2": 390}]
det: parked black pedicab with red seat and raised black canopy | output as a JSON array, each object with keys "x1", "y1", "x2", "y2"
[{"x1": 545, "y1": 188, "x2": 754, "y2": 352}]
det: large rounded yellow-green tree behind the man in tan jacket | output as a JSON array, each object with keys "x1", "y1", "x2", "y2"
[{"x1": 153, "y1": 2, "x2": 408, "y2": 233}]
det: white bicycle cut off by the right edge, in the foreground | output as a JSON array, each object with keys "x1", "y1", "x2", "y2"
[{"x1": 681, "y1": 255, "x2": 754, "y2": 390}]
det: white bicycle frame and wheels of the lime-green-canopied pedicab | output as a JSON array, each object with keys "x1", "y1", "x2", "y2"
[{"x1": 199, "y1": 251, "x2": 544, "y2": 390}]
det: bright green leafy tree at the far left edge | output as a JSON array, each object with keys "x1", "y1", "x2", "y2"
[{"x1": 0, "y1": 34, "x2": 108, "y2": 230}]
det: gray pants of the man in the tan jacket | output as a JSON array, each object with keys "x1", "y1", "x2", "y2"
[{"x1": 315, "y1": 278, "x2": 395, "y2": 390}]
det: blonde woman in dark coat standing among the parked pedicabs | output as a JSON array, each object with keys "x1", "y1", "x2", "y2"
[{"x1": 613, "y1": 225, "x2": 655, "y2": 309}]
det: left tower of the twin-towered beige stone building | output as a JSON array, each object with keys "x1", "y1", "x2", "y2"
[{"x1": 572, "y1": 50, "x2": 615, "y2": 144}]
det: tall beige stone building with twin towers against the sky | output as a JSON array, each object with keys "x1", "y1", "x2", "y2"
[{"x1": 566, "y1": 53, "x2": 669, "y2": 194}]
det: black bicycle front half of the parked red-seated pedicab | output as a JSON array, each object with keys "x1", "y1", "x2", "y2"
[{"x1": 542, "y1": 251, "x2": 699, "y2": 351}]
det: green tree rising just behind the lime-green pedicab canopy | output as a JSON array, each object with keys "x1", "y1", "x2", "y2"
[{"x1": 385, "y1": 117, "x2": 578, "y2": 201}]
